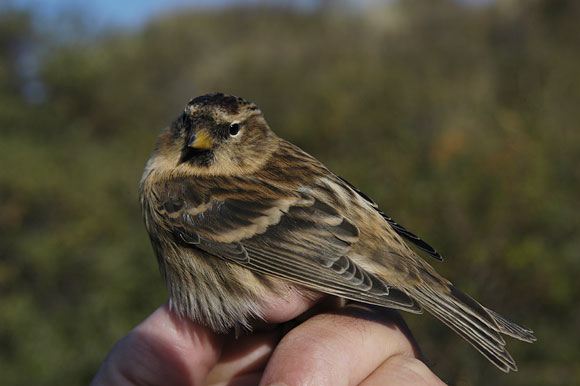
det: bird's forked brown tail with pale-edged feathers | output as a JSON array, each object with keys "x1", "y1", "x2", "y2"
[{"x1": 407, "y1": 283, "x2": 536, "y2": 372}]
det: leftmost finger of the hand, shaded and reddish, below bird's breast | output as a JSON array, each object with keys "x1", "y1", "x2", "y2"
[{"x1": 91, "y1": 305, "x2": 223, "y2": 386}]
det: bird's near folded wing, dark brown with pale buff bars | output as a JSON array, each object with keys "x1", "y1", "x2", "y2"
[{"x1": 154, "y1": 179, "x2": 420, "y2": 312}]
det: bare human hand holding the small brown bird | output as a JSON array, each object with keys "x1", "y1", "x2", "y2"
[{"x1": 91, "y1": 295, "x2": 444, "y2": 386}]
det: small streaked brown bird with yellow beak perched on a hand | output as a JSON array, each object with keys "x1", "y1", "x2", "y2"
[{"x1": 140, "y1": 94, "x2": 535, "y2": 372}]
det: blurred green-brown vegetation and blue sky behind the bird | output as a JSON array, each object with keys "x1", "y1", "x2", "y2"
[{"x1": 0, "y1": 0, "x2": 580, "y2": 385}]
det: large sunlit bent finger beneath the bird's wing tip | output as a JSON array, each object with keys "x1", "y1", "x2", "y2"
[{"x1": 261, "y1": 304, "x2": 419, "y2": 386}]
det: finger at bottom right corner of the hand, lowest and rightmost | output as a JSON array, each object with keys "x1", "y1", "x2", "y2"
[{"x1": 360, "y1": 355, "x2": 445, "y2": 386}]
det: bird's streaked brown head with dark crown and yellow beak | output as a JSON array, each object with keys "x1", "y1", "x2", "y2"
[{"x1": 156, "y1": 93, "x2": 277, "y2": 175}]
